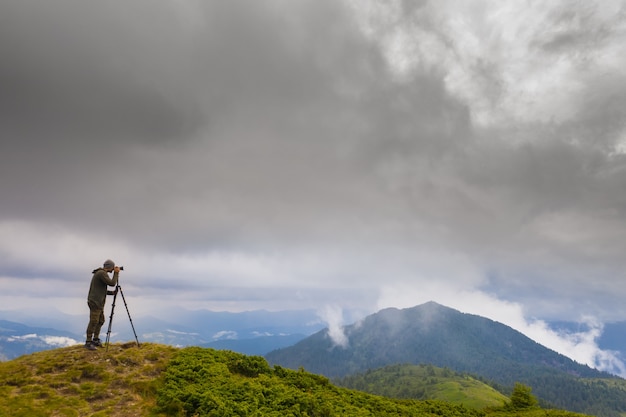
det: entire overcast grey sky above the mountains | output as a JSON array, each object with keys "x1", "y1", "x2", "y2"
[{"x1": 0, "y1": 0, "x2": 626, "y2": 372}]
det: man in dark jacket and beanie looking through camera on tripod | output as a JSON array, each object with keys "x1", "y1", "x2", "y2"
[{"x1": 85, "y1": 259, "x2": 120, "y2": 350}]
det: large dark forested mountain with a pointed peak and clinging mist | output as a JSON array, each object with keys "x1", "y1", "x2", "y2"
[{"x1": 265, "y1": 302, "x2": 626, "y2": 417}]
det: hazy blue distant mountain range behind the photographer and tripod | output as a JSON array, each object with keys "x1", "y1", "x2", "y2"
[{"x1": 0, "y1": 306, "x2": 325, "y2": 361}]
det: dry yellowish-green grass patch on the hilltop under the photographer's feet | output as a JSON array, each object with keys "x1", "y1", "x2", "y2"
[{"x1": 0, "y1": 344, "x2": 176, "y2": 417}]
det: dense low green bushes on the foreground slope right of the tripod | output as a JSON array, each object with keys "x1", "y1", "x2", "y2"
[{"x1": 156, "y1": 348, "x2": 484, "y2": 417}]
